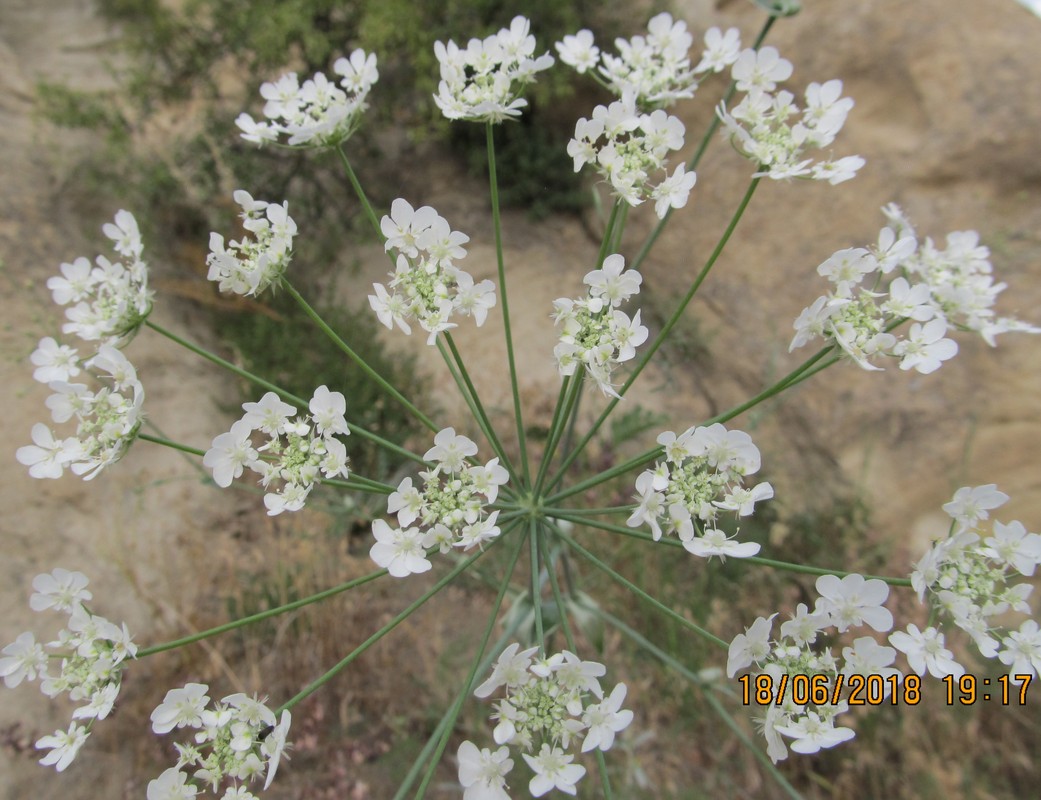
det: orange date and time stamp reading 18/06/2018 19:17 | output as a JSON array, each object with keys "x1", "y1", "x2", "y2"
[{"x1": 737, "y1": 673, "x2": 1033, "y2": 706}]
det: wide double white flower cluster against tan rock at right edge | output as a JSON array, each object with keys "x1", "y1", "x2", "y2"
[{"x1": 789, "y1": 205, "x2": 1041, "y2": 374}]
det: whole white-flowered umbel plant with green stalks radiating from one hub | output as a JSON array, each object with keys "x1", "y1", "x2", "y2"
[{"x1": 8, "y1": 0, "x2": 1041, "y2": 800}]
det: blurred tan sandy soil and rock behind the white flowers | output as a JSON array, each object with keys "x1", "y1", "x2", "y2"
[{"x1": 0, "y1": 0, "x2": 1041, "y2": 800}]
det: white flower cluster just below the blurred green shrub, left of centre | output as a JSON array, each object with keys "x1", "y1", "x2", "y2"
[{"x1": 203, "y1": 385, "x2": 351, "y2": 517}]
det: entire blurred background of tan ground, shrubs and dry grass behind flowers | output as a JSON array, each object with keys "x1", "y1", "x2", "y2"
[{"x1": 0, "y1": 0, "x2": 1041, "y2": 800}]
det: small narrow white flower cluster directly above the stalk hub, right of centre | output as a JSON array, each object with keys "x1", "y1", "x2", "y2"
[{"x1": 553, "y1": 253, "x2": 648, "y2": 397}]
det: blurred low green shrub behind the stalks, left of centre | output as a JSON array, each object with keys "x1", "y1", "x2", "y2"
[{"x1": 217, "y1": 295, "x2": 425, "y2": 479}]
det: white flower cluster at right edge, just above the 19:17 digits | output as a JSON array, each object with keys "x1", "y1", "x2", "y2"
[{"x1": 903, "y1": 483, "x2": 1041, "y2": 682}]
